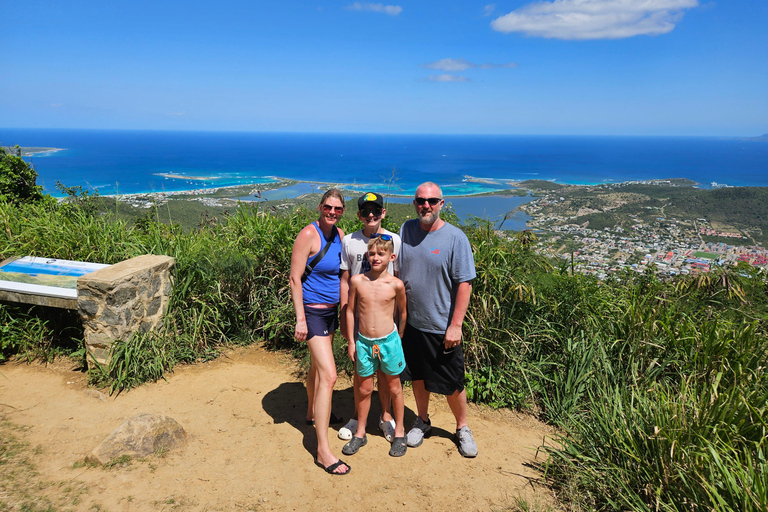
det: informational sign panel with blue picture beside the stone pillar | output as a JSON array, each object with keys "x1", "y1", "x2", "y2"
[{"x1": 0, "y1": 256, "x2": 109, "y2": 299}]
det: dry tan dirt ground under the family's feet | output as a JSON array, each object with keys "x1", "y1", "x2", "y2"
[{"x1": 0, "y1": 346, "x2": 557, "y2": 512}]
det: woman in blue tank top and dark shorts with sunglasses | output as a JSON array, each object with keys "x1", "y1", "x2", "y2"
[{"x1": 290, "y1": 189, "x2": 351, "y2": 475}]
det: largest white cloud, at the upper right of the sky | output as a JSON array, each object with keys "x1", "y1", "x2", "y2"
[{"x1": 491, "y1": 0, "x2": 699, "y2": 40}]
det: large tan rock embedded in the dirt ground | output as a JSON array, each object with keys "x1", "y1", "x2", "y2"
[{"x1": 85, "y1": 414, "x2": 187, "y2": 464}]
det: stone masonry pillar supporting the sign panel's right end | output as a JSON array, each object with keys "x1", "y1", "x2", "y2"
[{"x1": 77, "y1": 255, "x2": 175, "y2": 364}]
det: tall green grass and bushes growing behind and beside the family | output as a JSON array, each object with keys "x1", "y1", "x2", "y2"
[{"x1": 0, "y1": 150, "x2": 768, "y2": 512}]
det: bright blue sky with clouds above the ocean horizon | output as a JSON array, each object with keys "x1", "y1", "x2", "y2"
[{"x1": 0, "y1": 0, "x2": 768, "y2": 136}]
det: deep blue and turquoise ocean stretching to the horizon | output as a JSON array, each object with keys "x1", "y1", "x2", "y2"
[{"x1": 0, "y1": 128, "x2": 768, "y2": 229}]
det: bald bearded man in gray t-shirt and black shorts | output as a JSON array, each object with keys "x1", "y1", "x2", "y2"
[{"x1": 400, "y1": 182, "x2": 477, "y2": 457}]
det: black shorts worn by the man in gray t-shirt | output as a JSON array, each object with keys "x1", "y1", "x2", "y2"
[{"x1": 400, "y1": 324, "x2": 464, "y2": 395}]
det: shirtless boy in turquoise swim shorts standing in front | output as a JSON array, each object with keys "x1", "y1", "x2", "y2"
[{"x1": 341, "y1": 233, "x2": 407, "y2": 457}]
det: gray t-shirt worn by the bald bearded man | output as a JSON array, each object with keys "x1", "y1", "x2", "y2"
[{"x1": 400, "y1": 219, "x2": 475, "y2": 334}]
